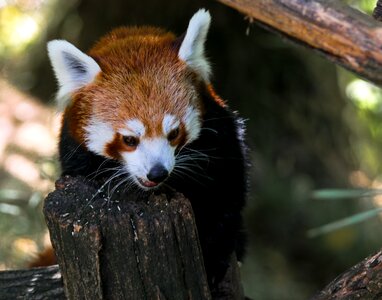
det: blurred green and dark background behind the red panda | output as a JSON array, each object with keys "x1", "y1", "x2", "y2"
[{"x1": 0, "y1": 0, "x2": 382, "y2": 300}]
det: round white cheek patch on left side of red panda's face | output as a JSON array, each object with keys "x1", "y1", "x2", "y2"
[{"x1": 85, "y1": 118, "x2": 114, "y2": 156}]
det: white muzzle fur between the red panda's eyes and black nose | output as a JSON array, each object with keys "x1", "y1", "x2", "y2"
[{"x1": 122, "y1": 137, "x2": 175, "y2": 189}]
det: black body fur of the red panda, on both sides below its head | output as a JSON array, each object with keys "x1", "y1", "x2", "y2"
[{"x1": 59, "y1": 83, "x2": 247, "y2": 290}]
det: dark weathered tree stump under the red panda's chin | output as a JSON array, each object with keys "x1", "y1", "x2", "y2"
[{"x1": 44, "y1": 177, "x2": 213, "y2": 300}]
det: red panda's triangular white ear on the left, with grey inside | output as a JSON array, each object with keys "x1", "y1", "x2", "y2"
[{"x1": 48, "y1": 40, "x2": 101, "y2": 109}]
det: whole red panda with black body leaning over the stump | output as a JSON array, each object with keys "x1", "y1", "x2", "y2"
[{"x1": 48, "y1": 9, "x2": 247, "y2": 290}]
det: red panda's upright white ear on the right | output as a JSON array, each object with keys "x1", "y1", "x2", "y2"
[{"x1": 178, "y1": 9, "x2": 211, "y2": 82}]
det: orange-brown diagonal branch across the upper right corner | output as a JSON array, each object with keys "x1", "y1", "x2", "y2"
[{"x1": 218, "y1": 0, "x2": 382, "y2": 85}]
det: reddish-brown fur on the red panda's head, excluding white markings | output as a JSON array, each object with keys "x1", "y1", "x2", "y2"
[{"x1": 64, "y1": 27, "x2": 201, "y2": 159}]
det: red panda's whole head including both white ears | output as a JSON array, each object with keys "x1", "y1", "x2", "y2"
[{"x1": 48, "y1": 10, "x2": 210, "y2": 189}]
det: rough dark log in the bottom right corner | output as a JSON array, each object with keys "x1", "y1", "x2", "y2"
[{"x1": 312, "y1": 250, "x2": 382, "y2": 300}]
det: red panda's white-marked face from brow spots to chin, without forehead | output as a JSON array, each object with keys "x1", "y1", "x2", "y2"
[{"x1": 85, "y1": 108, "x2": 200, "y2": 187}]
